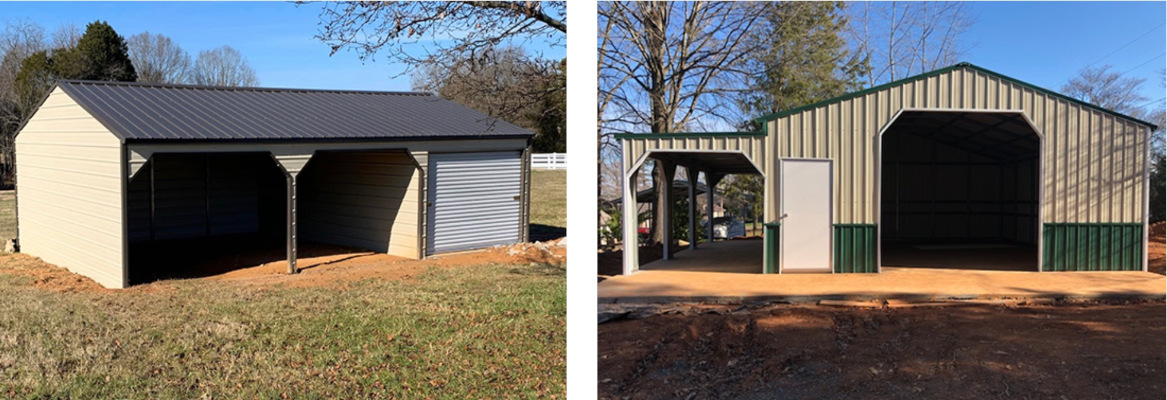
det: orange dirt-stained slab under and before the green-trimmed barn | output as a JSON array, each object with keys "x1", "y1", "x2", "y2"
[{"x1": 599, "y1": 240, "x2": 1167, "y2": 303}]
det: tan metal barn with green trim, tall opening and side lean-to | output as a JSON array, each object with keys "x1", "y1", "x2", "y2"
[{"x1": 619, "y1": 63, "x2": 1155, "y2": 274}]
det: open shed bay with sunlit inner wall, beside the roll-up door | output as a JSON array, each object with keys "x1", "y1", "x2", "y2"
[{"x1": 299, "y1": 152, "x2": 421, "y2": 259}]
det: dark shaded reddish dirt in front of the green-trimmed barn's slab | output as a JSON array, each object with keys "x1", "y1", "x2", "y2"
[{"x1": 599, "y1": 302, "x2": 1167, "y2": 399}]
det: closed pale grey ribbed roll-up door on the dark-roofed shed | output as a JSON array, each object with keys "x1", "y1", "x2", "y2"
[{"x1": 426, "y1": 152, "x2": 523, "y2": 254}]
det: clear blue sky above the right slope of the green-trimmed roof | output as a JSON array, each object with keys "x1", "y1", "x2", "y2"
[{"x1": 964, "y1": 1, "x2": 1167, "y2": 104}]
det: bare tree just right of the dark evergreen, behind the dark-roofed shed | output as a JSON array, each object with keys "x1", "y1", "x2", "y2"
[{"x1": 126, "y1": 31, "x2": 190, "y2": 83}]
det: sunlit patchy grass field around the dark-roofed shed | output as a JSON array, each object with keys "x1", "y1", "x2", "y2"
[{"x1": 0, "y1": 171, "x2": 566, "y2": 399}]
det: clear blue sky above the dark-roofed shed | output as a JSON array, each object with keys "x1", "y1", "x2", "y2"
[{"x1": 0, "y1": 1, "x2": 565, "y2": 90}]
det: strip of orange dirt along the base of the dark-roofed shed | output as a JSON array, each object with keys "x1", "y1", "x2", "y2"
[{"x1": 0, "y1": 238, "x2": 567, "y2": 293}]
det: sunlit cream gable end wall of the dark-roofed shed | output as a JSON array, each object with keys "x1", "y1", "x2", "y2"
[{"x1": 16, "y1": 89, "x2": 127, "y2": 288}]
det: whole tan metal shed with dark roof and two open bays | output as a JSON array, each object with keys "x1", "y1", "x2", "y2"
[{"x1": 15, "y1": 80, "x2": 533, "y2": 288}]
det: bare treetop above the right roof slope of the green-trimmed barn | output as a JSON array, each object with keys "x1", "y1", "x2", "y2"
[{"x1": 1062, "y1": 65, "x2": 1147, "y2": 113}]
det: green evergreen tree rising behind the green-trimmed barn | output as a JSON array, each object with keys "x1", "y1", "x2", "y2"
[{"x1": 742, "y1": 1, "x2": 869, "y2": 115}]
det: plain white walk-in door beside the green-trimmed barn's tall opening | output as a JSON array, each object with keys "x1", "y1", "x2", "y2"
[{"x1": 778, "y1": 160, "x2": 831, "y2": 272}]
